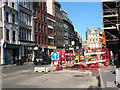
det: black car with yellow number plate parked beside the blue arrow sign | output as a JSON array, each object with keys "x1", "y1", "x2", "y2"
[{"x1": 33, "y1": 53, "x2": 51, "y2": 65}]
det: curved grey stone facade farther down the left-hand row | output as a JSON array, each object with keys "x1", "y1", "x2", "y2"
[{"x1": 62, "y1": 11, "x2": 74, "y2": 46}]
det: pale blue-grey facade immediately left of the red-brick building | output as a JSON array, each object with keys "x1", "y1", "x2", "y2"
[{"x1": 18, "y1": 1, "x2": 35, "y2": 61}]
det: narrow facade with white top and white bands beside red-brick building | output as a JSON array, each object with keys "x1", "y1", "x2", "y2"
[{"x1": 47, "y1": 0, "x2": 56, "y2": 54}]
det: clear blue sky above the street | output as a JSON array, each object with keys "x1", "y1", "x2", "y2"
[{"x1": 59, "y1": 2, "x2": 102, "y2": 40}]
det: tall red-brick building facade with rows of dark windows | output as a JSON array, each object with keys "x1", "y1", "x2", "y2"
[{"x1": 33, "y1": 0, "x2": 48, "y2": 53}]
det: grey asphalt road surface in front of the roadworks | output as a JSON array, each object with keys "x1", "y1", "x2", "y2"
[{"x1": 2, "y1": 63, "x2": 98, "y2": 88}]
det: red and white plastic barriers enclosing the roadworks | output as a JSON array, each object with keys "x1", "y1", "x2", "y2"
[{"x1": 60, "y1": 48, "x2": 110, "y2": 70}]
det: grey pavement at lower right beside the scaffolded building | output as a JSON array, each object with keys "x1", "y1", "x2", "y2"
[{"x1": 99, "y1": 66, "x2": 120, "y2": 90}]
